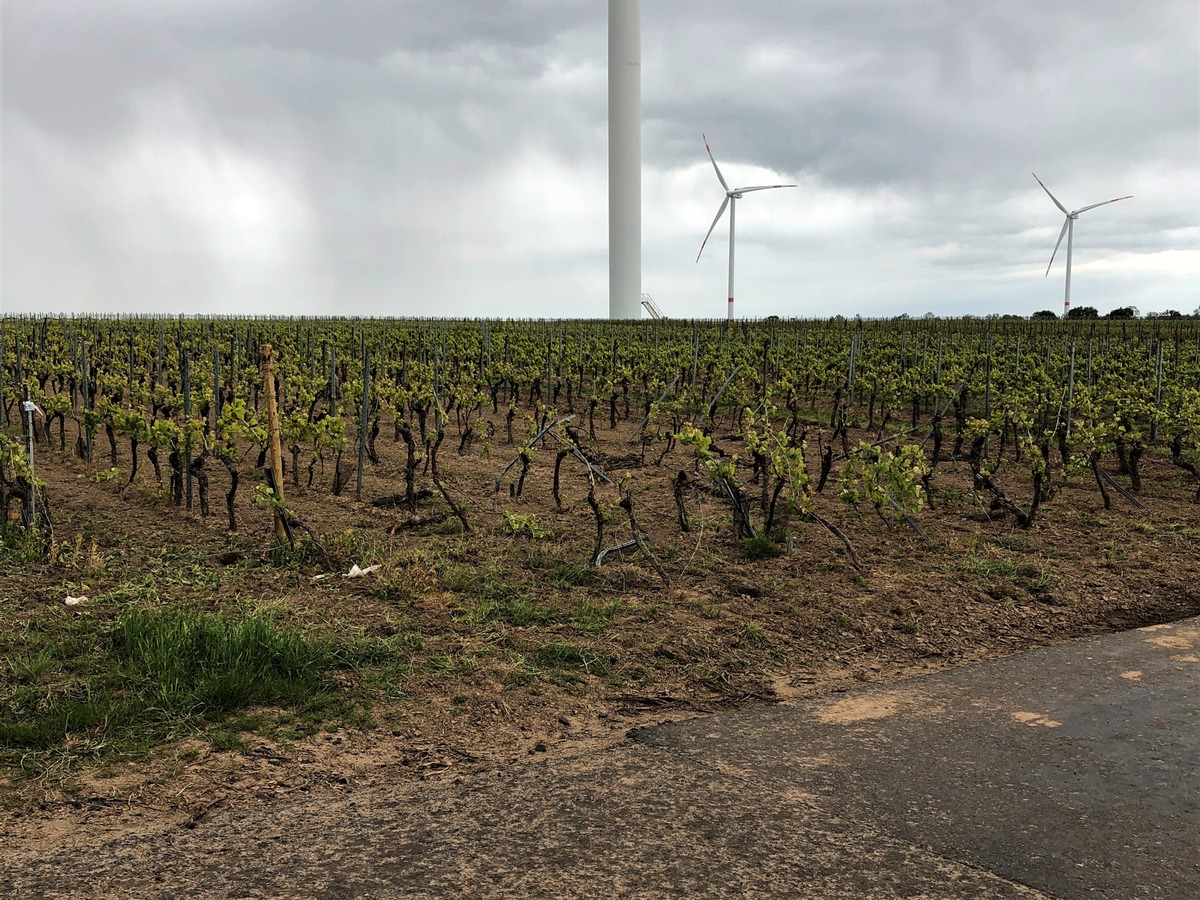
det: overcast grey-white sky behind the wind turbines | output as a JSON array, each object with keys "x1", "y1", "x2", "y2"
[{"x1": 0, "y1": 0, "x2": 1200, "y2": 318}]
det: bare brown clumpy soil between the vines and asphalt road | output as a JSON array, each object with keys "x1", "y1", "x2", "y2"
[{"x1": 0, "y1": 415, "x2": 1200, "y2": 848}]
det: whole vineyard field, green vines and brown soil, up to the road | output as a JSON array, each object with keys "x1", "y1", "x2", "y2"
[{"x1": 0, "y1": 317, "x2": 1200, "y2": 806}]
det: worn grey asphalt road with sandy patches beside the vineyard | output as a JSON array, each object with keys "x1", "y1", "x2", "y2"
[{"x1": 0, "y1": 619, "x2": 1200, "y2": 900}]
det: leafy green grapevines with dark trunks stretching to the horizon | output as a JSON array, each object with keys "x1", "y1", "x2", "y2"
[{"x1": 0, "y1": 317, "x2": 1200, "y2": 578}]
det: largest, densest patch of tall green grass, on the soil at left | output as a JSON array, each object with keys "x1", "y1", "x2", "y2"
[{"x1": 0, "y1": 607, "x2": 350, "y2": 772}]
